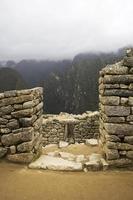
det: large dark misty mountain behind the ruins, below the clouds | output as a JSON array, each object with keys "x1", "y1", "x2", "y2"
[{"x1": 1, "y1": 49, "x2": 124, "y2": 114}]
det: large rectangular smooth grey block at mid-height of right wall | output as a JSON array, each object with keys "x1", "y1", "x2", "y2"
[{"x1": 104, "y1": 106, "x2": 130, "y2": 116}]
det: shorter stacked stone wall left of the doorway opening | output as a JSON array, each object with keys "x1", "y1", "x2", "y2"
[{"x1": 0, "y1": 87, "x2": 43, "y2": 163}]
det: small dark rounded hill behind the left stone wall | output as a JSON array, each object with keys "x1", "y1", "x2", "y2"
[{"x1": 0, "y1": 67, "x2": 27, "y2": 92}]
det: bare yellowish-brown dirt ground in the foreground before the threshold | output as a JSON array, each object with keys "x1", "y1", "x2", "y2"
[{"x1": 0, "y1": 161, "x2": 133, "y2": 200}]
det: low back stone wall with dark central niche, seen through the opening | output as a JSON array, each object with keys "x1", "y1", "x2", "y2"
[{"x1": 42, "y1": 112, "x2": 99, "y2": 146}]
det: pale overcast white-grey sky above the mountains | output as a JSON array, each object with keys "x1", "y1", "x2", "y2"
[{"x1": 0, "y1": 0, "x2": 133, "y2": 60}]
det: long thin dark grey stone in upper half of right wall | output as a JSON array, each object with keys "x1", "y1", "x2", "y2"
[{"x1": 104, "y1": 89, "x2": 133, "y2": 97}]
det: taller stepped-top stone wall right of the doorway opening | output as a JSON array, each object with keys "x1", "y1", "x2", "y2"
[{"x1": 99, "y1": 50, "x2": 133, "y2": 167}]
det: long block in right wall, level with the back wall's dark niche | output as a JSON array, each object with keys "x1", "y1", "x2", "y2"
[{"x1": 104, "y1": 123, "x2": 133, "y2": 136}]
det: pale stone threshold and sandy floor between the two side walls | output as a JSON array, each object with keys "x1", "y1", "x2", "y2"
[{"x1": 29, "y1": 139, "x2": 108, "y2": 172}]
